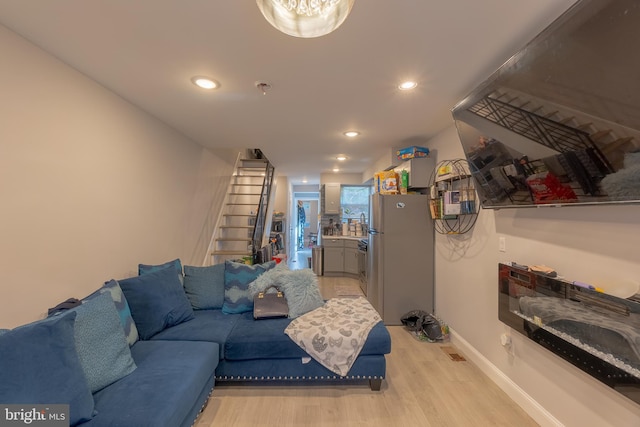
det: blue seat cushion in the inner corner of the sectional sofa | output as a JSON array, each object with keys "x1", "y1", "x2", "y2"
[{"x1": 151, "y1": 309, "x2": 240, "y2": 359}]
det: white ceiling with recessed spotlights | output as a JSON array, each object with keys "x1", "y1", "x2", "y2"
[{"x1": 0, "y1": 0, "x2": 573, "y2": 184}]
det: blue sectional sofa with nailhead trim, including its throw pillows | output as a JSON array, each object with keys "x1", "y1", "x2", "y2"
[{"x1": 0, "y1": 260, "x2": 391, "y2": 427}]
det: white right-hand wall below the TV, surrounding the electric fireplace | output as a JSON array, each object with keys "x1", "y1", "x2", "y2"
[{"x1": 429, "y1": 126, "x2": 640, "y2": 427}]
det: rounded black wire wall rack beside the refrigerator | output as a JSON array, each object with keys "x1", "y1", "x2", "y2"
[{"x1": 429, "y1": 159, "x2": 480, "y2": 234}]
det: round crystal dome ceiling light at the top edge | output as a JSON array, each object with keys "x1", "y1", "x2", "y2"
[{"x1": 256, "y1": 0, "x2": 355, "y2": 38}]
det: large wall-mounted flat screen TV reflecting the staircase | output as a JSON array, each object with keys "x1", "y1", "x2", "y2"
[{"x1": 452, "y1": 0, "x2": 640, "y2": 209}]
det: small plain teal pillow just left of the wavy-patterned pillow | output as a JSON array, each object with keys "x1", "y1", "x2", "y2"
[{"x1": 184, "y1": 263, "x2": 225, "y2": 310}]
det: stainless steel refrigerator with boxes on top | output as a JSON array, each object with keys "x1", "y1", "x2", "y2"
[{"x1": 367, "y1": 193, "x2": 434, "y2": 325}]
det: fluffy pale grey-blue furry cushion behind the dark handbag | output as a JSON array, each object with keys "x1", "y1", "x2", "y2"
[{"x1": 249, "y1": 263, "x2": 324, "y2": 319}]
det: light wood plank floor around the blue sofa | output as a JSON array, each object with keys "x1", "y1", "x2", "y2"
[{"x1": 195, "y1": 276, "x2": 537, "y2": 427}]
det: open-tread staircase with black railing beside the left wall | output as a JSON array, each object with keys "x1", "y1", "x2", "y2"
[{"x1": 210, "y1": 150, "x2": 275, "y2": 264}]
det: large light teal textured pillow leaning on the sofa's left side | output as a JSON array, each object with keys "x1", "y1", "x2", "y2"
[{"x1": 64, "y1": 293, "x2": 136, "y2": 393}]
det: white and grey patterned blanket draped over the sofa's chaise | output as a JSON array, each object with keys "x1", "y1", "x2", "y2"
[{"x1": 284, "y1": 297, "x2": 381, "y2": 376}]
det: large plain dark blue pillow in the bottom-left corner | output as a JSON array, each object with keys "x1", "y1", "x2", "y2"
[{"x1": 0, "y1": 312, "x2": 94, "y2": 426}]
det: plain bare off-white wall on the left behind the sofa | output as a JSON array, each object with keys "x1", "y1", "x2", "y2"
[{"x1": 0, "y1": 26, "x2": 235, "y2": 328}]
